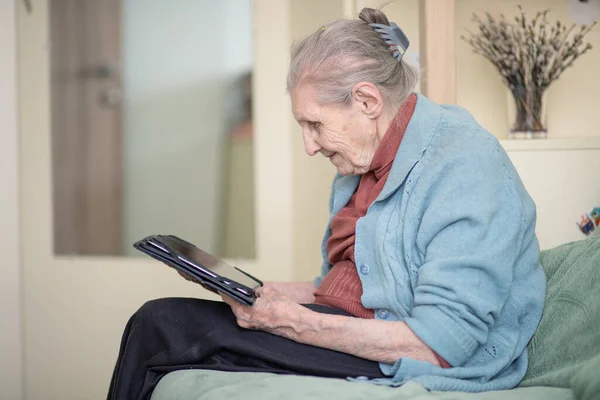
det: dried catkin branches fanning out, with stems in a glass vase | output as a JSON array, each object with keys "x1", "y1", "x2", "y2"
[{"x1": 461, "y1": 6, "x2": 596, "y2": 131}]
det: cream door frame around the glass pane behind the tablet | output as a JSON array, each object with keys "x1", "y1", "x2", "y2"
[{"x1": 16, "y1": 0, "x2": 293, "y2": 400}]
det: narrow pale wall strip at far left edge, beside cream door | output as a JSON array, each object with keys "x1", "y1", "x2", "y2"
[{"x1": 0, "y1": 1, "x2": 23, "y2": 400}]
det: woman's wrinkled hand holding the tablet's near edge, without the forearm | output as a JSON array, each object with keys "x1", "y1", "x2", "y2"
[{"x1": 220, "y1": 286, "x2": 308, "y2": 339}]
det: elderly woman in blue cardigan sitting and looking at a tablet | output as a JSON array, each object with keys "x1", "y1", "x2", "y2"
[{"x1": 109, "y1": 9, "x2": 545, "y2": 399}]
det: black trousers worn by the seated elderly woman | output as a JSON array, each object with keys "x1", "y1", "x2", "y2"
[{"x1": 108, "y1": 298, "x2": 384, "y2": 400}]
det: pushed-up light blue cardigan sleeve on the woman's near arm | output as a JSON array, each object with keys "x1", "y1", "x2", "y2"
[{"x1": 405, "y1": 149, "x2": 525, "y2": 366}]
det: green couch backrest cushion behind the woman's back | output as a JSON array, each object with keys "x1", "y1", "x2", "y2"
[{"x1": 521, "y1": 236, "x2": 600, "y2": 387}]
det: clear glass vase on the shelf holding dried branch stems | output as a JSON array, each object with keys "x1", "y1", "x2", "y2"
[{"x1": 508, "y1": 86, "x2": 548, "y2": 139}]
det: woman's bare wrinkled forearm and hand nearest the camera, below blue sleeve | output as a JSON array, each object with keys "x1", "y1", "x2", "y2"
[{"x1": 222, "y1": 286, "x2": 440, "y2": 366}]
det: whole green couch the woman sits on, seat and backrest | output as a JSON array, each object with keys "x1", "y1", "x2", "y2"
[{"x1": 152, "y1": 236, "x2": 600, "y2": 400}]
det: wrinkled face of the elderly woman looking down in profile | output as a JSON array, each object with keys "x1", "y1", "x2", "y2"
[{"x1": 290, "y1": 83, "x2": 379, "y2": 175}]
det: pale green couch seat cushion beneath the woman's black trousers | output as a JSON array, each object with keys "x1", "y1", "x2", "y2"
[{"x1": 151, "y1": 370, "x2": 574, "y2": 400}]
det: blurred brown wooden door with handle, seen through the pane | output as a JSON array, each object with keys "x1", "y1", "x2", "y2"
[{"x1": 49, "y1": 0, "x2": 123, "y2": 255}]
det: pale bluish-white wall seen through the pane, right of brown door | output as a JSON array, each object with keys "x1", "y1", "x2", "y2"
[{"x1": 122, "y1": 0, "x2": 252, "y2": 255}]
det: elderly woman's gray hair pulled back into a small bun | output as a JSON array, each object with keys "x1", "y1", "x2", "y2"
[{"x1": 287, "y1": 8, "x2": 419, "y2": 110}]
